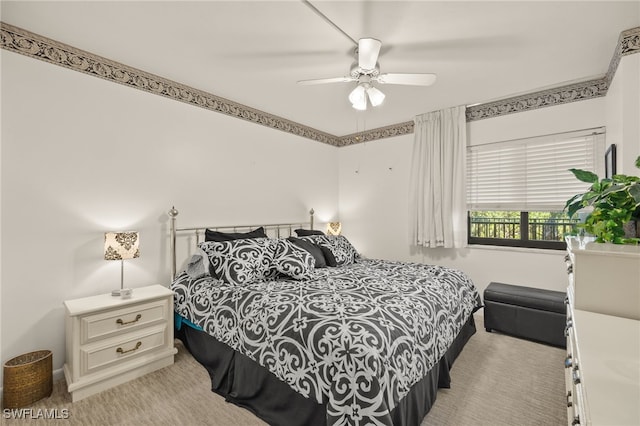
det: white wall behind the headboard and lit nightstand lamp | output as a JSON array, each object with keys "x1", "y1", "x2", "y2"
[{"x1": 0, "y1": 50, "x2": 338, "y2": 382}]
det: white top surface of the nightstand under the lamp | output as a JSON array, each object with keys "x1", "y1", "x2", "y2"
[{"x1": 64, "y1": 285, "x2": 173, "y2": 316}]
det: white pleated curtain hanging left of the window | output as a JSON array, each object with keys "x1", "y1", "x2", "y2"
[{"x1": 409, "y1": 106, "x2": 467, "y2": 248}]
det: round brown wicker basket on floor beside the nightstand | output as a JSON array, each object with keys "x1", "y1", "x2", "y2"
[{"x1": 2, "y1": 350, "x2": 53, "y2": 408}]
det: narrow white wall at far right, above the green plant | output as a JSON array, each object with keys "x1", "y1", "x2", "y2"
[{"x1": 607, "y1": 54, "x2": 640, "y2": 176}]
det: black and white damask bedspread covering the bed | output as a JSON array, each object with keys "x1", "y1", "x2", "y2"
[{"x1": 172, "y1": 259, "x2": 481, "y2": 425}]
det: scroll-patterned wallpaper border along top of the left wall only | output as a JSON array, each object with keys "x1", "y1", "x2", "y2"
[{"x1": 0, "y1": 22, "x2": 338, "y2": 146}]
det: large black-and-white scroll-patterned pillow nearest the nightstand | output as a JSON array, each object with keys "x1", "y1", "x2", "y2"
[{"x1": 199, "y1": 238, "x2": 278, "y2": 285}]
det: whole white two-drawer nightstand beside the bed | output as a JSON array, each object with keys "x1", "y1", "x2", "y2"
[{"x1": 64, "y1": 285, "x2": 177, "y2": 402}]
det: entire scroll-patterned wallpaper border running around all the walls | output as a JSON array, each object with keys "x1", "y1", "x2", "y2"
[{"x1": 0, "y1": 22, "x2": 640, "y2": 147}]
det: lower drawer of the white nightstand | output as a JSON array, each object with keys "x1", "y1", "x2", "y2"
[{"x1": 80, "y1": 323, "x2": 167, "y2": 375}]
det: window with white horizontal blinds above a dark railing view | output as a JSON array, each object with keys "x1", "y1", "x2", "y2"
[{"x1": 467, "y1": 128, "x2": 604, "y2": 249}]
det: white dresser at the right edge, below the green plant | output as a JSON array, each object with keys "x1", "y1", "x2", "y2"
[{"x1": 565, "y1": 239, "x2": 640, "y2": 426}]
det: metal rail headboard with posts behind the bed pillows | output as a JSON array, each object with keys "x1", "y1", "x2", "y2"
[{"x1": 168, "y1": 207, "x2": 315, "y2": 280}]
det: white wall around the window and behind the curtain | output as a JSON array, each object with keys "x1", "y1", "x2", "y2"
[{"x1": 339, "y1": 98, "x2": 605, "y2": 292}]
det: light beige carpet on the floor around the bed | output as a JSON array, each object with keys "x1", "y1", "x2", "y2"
[{"x1": 0, "y1": 310, "x2": 567, "y2": 426}]
